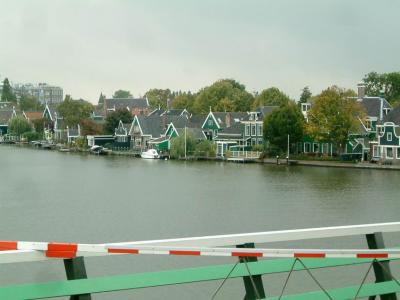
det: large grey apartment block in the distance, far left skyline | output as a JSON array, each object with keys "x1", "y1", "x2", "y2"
[{"x1": 13, "y1": 83, "x2": 64, "y2": 104}]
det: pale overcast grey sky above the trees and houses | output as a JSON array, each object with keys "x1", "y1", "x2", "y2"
[{"x1": 0, "y1": 0, "x2": 400, "y2": 102}]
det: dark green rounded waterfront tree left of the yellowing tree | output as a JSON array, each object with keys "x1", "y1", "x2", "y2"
[{"x1": 263, "y1": 101, "x2": 305, "y2": 153}]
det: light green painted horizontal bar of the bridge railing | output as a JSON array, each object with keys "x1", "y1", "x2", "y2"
[{"x1": 0, "y1": 258, "x2": 400, "y2": 300}]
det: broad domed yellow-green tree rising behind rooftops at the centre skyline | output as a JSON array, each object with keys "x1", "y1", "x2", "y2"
[{"x1": 193, "y1": 79, "x2": 254, "y2": 113}]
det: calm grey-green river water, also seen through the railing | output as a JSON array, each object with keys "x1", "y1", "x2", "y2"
[{"x1": 0, "y1": 146, "x2": 400, "y2": 299}]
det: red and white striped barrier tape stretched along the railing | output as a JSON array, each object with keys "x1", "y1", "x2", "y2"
[{"x1": 0, "y1": 241, "x2": 400, "y2": 259}]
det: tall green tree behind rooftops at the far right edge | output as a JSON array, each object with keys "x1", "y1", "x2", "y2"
[{"x1": 363, "y1": 72, "x2": 400, "y2": 103}]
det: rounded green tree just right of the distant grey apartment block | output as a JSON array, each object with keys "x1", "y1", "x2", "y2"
[{"x1": 58, "y1": 95, "x2": 93, "y2": 127}]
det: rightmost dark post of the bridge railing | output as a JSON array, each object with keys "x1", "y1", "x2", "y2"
[{"x1": 366, "y1": 232, "x2": 397, "y2": 300}]
